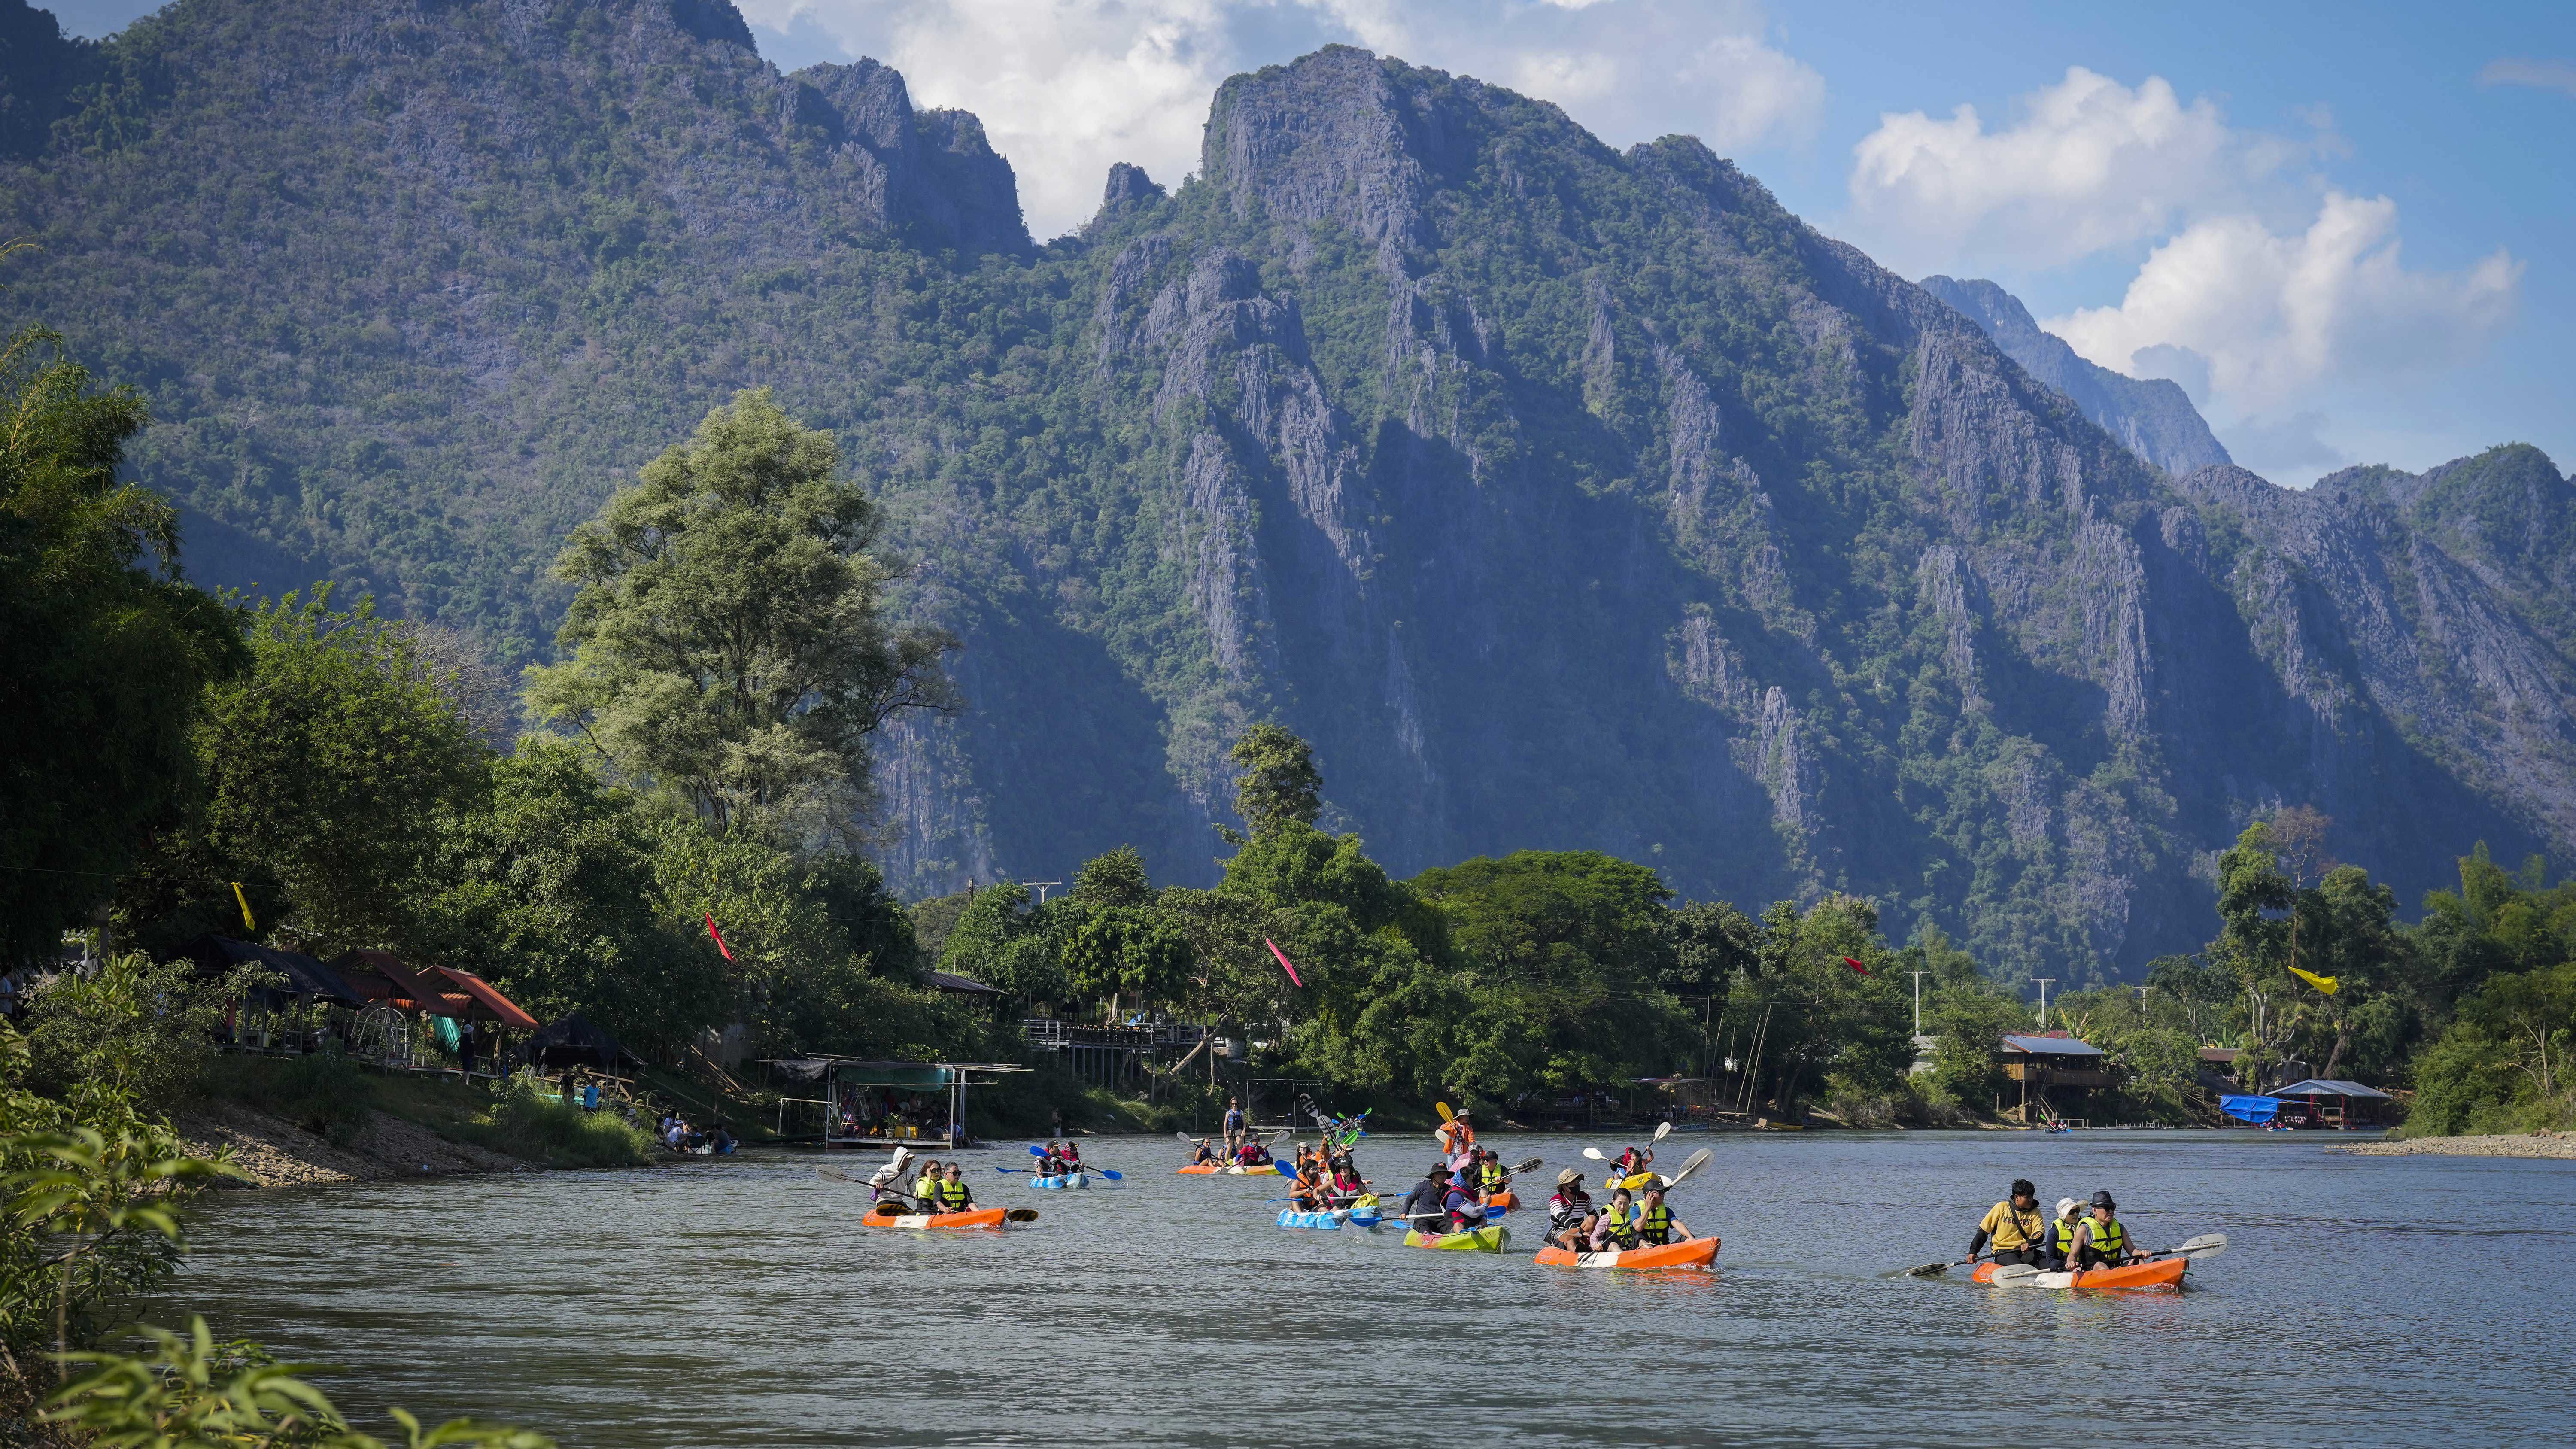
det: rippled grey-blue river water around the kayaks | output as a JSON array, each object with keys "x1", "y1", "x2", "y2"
[{"x1": 162, "y1": 1132, "x2": 2576, "y2": 1446}]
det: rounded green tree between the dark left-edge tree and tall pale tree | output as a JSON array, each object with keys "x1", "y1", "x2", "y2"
[{"x1": 121, "y1": 585, "x2": 492, "y2": 954}]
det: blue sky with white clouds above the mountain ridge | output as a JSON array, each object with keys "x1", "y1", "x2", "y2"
[{"x1": 57, "y1": 0, "x2": 2576, "y2": 485}]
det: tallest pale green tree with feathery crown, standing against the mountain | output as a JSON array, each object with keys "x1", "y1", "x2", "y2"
[{"x1": 528, "y1": 389, "x2": 953, "y2": 841}]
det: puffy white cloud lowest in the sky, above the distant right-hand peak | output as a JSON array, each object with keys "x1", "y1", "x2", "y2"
[{"x1": 2040, "y1": 193, "x2": 2522, "y2": 413}]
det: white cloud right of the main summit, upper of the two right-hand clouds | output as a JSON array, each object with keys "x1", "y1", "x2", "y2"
[{"x1": 1850, "y1": 67, "x2": 2331, "y2": 271}]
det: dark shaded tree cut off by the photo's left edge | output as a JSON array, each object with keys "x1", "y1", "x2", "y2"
[{"x1": 0, "y1": 328, "x2": 245, "y2": 967}]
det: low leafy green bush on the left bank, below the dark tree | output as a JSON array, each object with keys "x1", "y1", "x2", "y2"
[{"x1": 28, "y1": 951, "x2": 263, "y2": 1109}]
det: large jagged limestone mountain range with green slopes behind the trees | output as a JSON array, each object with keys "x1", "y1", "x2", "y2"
[{"x1": 0, "y1": 0, "x2": 2576, "y2": 980}]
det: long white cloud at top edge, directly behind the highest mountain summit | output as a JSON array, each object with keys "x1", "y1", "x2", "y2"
[{"x1": 739, "y1": 0, "x2": 1824, "y2": 237}]
